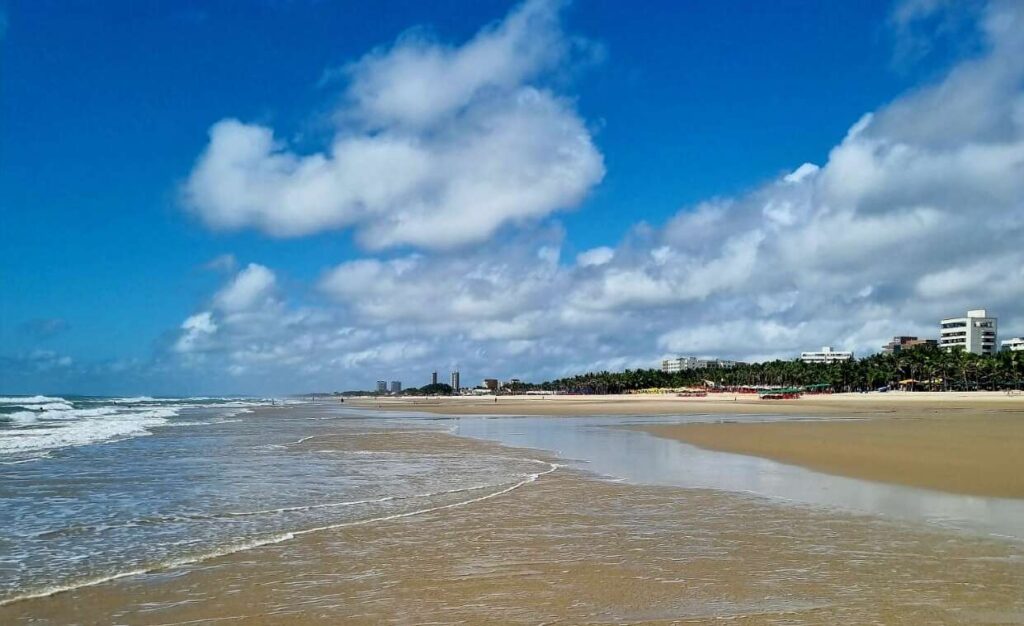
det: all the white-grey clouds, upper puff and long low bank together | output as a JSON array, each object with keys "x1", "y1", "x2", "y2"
[{"x1": 163, "y1": 2, "x2": 1024, "y2": 388}]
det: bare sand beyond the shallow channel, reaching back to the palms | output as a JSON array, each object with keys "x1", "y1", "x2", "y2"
[{"x1": 357, "y1": 392, "x2": 1024, "y2": 498}]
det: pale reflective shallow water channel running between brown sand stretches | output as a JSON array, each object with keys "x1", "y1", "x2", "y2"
[{"x1": 446, "y1": 415, "x2": 1024, "y2": 541}]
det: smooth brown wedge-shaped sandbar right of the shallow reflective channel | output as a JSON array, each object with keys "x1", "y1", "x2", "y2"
[{"x1": 643, "y1": 413, "x2": 1024, "y2": 498}]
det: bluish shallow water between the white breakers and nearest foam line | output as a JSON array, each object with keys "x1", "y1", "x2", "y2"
[{"x1": 0, "y1": 406, "x2": 547, "y2": 601}]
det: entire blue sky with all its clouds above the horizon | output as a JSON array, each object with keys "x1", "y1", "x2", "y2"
[{"x1": 0, "y1": 0, "x2": 1024, "y2": 394}]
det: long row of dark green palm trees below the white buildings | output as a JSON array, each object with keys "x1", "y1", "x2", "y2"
[{"x1": 522, "y1": 346, "x2": 1024, "y2": 393}]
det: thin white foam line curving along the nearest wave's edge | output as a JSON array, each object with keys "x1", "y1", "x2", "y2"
[{"x1": 0, "y1": 459, "x2": 562, "y2": 607}]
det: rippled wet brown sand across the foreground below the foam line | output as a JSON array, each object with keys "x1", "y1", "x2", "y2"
[{"x1": 8, "y1": 432, "x2": 1024, "y2": 624}]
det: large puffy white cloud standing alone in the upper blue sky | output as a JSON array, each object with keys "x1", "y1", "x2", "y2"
[{"x1": 184, "y1": 0, "x2": 604, "y2": 249}]
